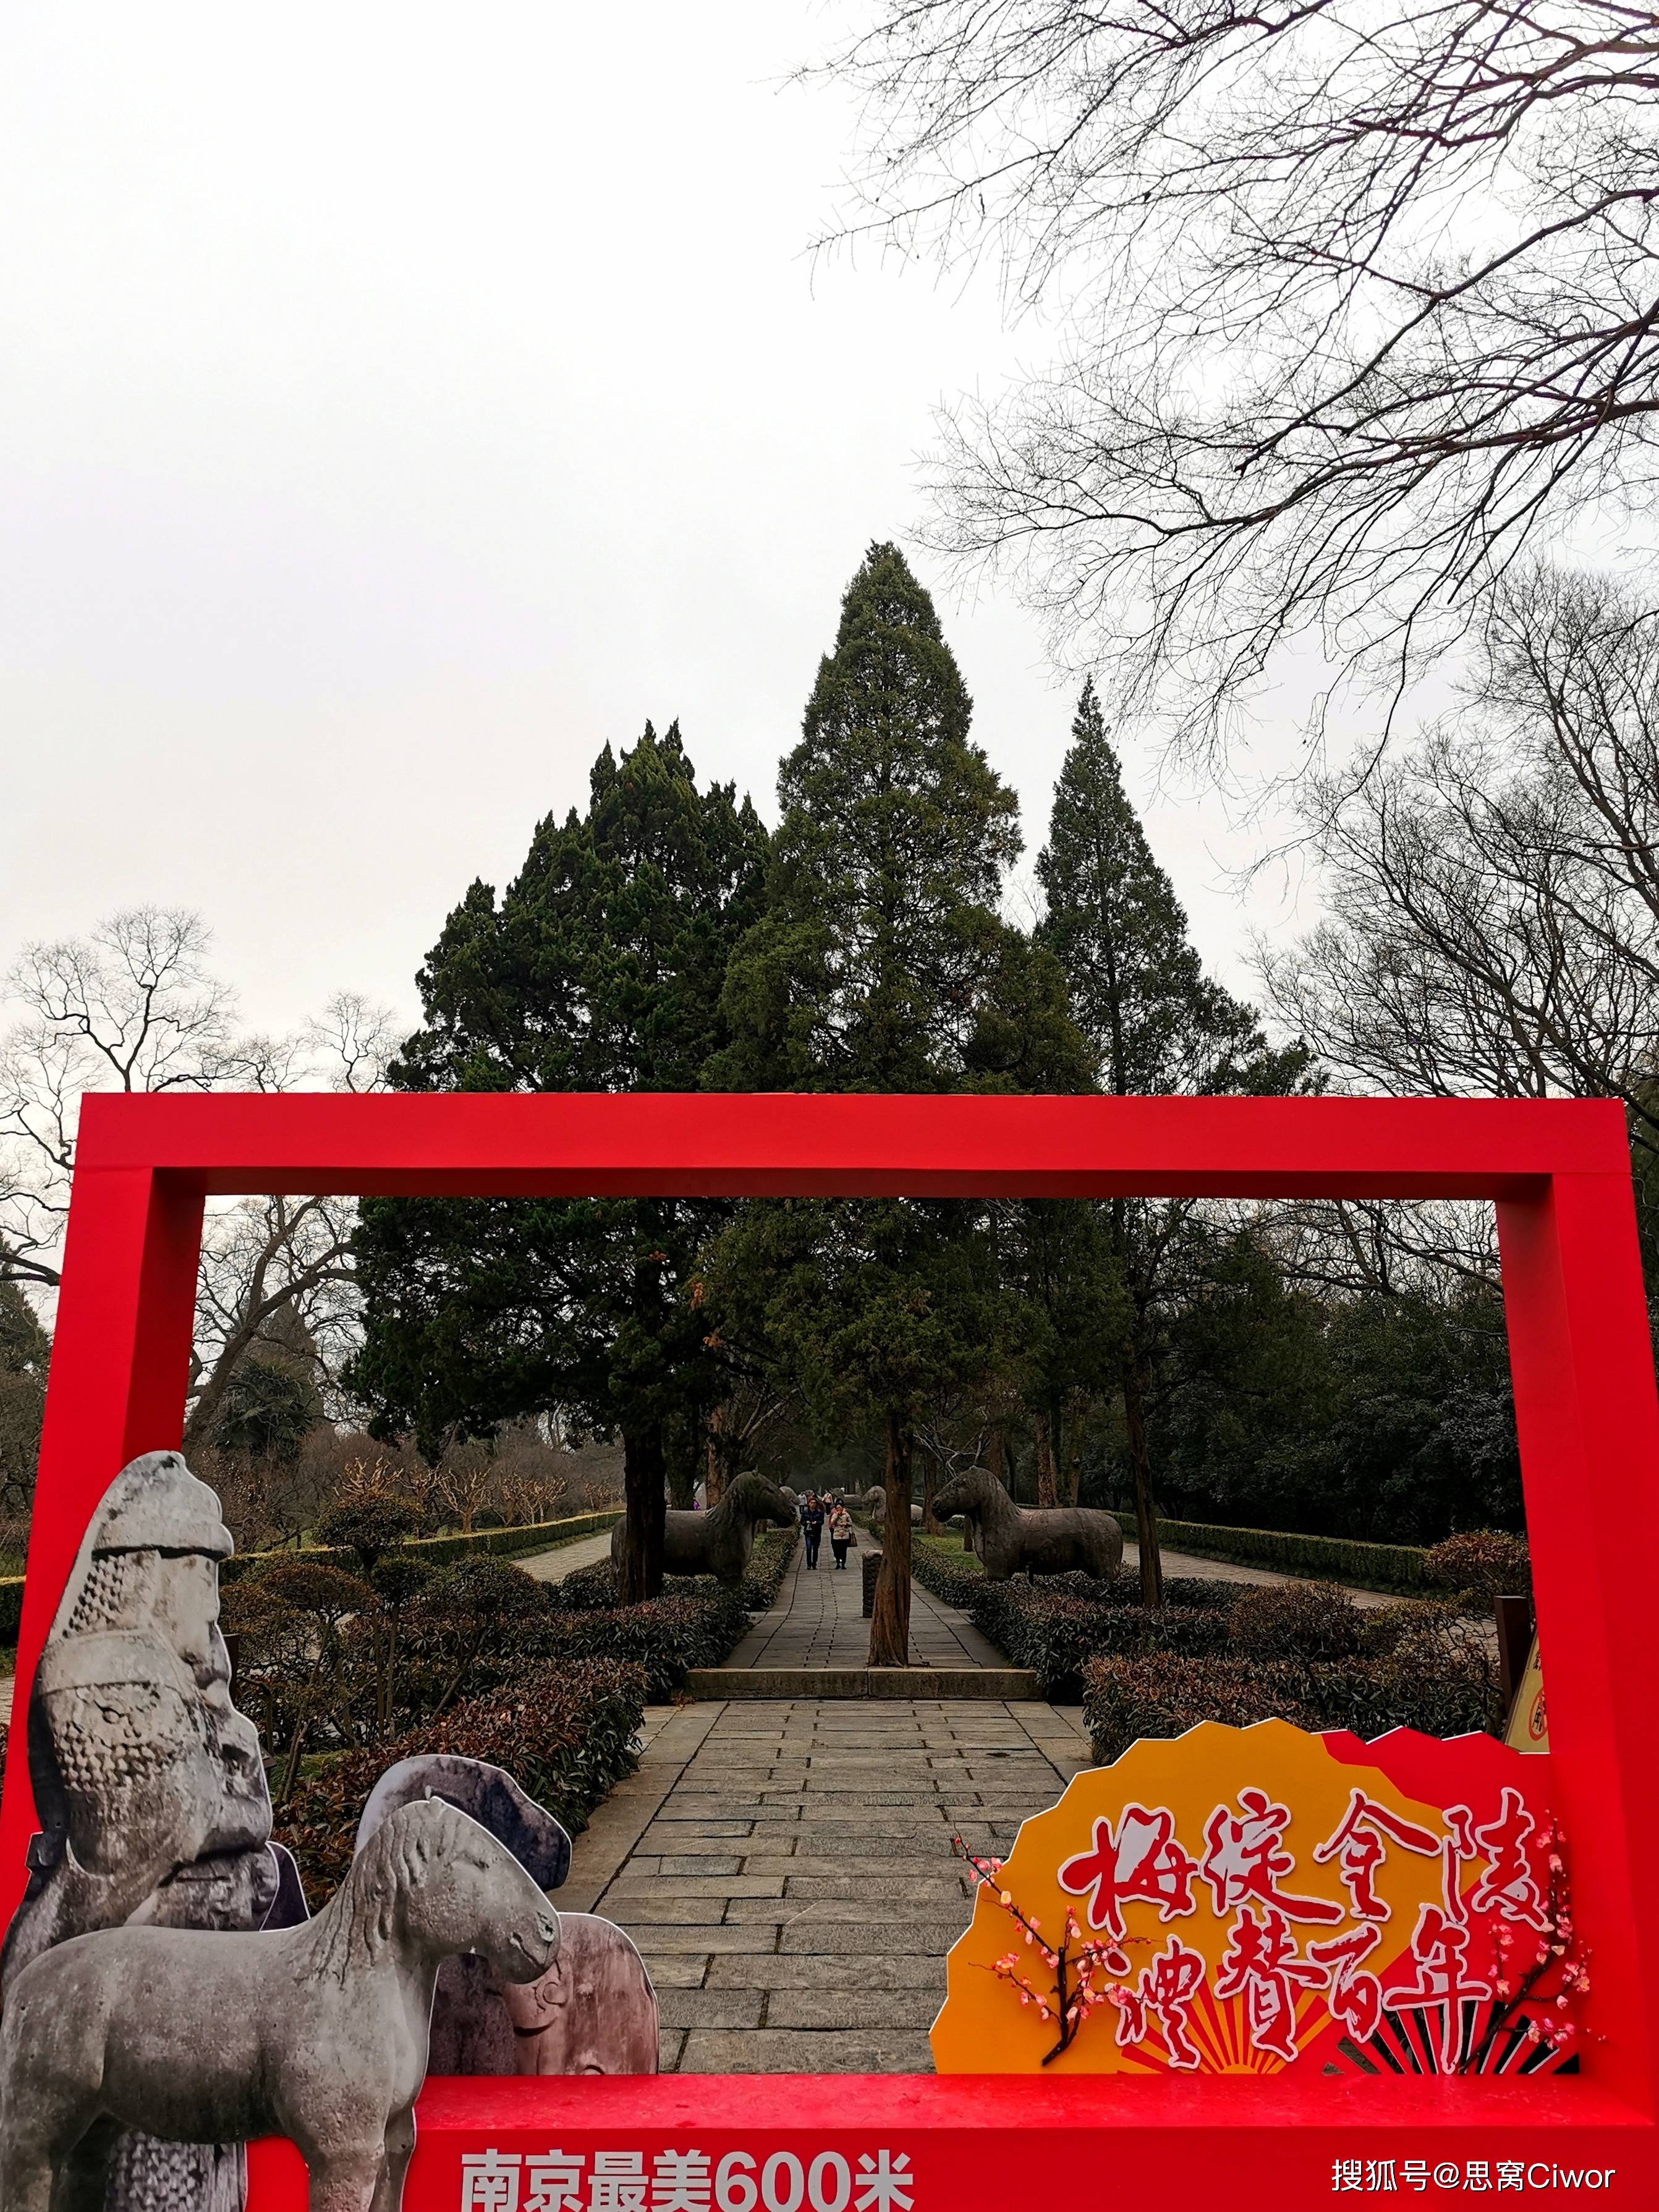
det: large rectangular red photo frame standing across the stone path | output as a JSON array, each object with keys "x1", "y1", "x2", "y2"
[{"x1": 0, "y1": 1093, "x2": 1659, "y2": 2212}]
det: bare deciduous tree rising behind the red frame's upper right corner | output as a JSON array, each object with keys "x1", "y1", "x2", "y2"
[{"x1": 1261, "y1": 571, "x2": 1659, "y2": 1157}]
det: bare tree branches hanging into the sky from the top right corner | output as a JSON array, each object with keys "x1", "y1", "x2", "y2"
[{"x1": 825, "y1": 0, "x2": 1659, "y2": 736}]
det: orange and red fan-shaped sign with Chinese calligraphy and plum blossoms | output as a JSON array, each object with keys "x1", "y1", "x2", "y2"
[{"x1": 933, "y1": 1721, "x2": 1588, "y2": 2075}]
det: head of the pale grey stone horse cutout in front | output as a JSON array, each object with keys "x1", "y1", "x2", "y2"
[{"x1": 345, "y1": 1798, "x2": 559, "y2": 1982}]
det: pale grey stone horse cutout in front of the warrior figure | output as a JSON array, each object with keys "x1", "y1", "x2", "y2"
[{"x1": 0, "y1": 1798, "x2": 559, "y2": 2212}]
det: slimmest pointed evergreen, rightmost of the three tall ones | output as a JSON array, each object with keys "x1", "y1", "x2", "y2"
[{"x1": 1037, "y1": 681, "x2": 1307, "y2": 1606}]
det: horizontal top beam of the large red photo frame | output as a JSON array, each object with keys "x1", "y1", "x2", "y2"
[{"x1": 77, "y1": 1093, "x2": 1630, "y2": 1199}]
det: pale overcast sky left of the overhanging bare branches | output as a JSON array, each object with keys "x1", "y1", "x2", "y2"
[{"x1": 0, "y1": 0, "x2": 1291, "y2": 1044}]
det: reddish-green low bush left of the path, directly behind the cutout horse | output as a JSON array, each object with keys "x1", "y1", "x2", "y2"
[{"x1": 276, "y1": 1659, "x2": 646, "y2": 1902}]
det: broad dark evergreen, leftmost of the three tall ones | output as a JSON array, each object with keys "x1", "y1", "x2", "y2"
[{"x1": 352, "y1": 723, "x2": 765, "y2": 1601}]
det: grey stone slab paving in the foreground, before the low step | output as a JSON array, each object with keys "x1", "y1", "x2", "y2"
[{"x1": 559, "y1": 1690, "x2": 1088, "y2": 2073}]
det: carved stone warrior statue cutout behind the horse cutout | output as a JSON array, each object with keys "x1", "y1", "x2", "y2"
[{"x1": 0, "y1": 1451, "x2": 279, "y2": 2212}]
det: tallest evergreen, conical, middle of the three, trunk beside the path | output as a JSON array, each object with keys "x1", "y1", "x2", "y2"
[{"x1": 708, "y1": 544, "x2": 1086, "y2": 1665}]
